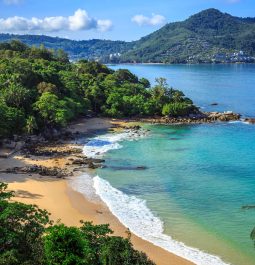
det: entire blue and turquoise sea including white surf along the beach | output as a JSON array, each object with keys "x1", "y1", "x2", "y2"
[{"x1": 72, "y1": 64, "x2": 255, "y2": 265}]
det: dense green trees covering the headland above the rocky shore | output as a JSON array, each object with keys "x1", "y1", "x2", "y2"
[{"x1": 0, "y1": 41, "x2": 197, "y2": 138}]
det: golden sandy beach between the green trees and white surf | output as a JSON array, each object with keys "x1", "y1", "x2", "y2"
[{"x1": 0, "y1": 118, "x2": 193, "y2": 265}]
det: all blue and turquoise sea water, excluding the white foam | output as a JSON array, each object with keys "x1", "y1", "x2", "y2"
[{"x1": 92, "y1": 65, "x2": 255, "y2": 265}]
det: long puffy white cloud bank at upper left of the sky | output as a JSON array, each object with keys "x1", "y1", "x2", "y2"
[{"x1": 0, "y1": 9, "x2": 112, "y2": 33}]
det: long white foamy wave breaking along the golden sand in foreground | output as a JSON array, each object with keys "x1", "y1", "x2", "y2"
[{"x1": 93, "y1": 176, "x2": 231, "y2": 265}]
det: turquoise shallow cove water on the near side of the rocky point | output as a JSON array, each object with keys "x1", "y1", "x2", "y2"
[{"x1": 94, "y1": 123, "x2": 255, "y2": 265}]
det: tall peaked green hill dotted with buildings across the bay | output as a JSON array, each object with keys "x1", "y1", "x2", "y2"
[{"x1": 122, "y1": 9, "x2": 255, "y2": 63}]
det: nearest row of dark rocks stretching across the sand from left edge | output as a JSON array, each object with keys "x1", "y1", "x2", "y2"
[{"x1": 0, "y1": 165, "x2": 72, "y2": 178}]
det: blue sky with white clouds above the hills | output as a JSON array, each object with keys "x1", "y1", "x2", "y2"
[{"x1": 0, "y1": 0, "x2": 255, "y2": 41}]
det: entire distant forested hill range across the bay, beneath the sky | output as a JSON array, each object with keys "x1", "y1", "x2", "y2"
[{"x1": 0, "y1": 9, "x2": 255, "y2": 63}]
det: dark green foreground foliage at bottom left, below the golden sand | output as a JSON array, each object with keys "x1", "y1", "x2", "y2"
[{"x1": 0, "y1": 183, "x2": 154, "y2": 265}]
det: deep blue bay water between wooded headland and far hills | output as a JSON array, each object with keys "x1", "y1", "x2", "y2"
[{"x1": 110, "y1": 64, "x2": 255, "y2": 116}]
